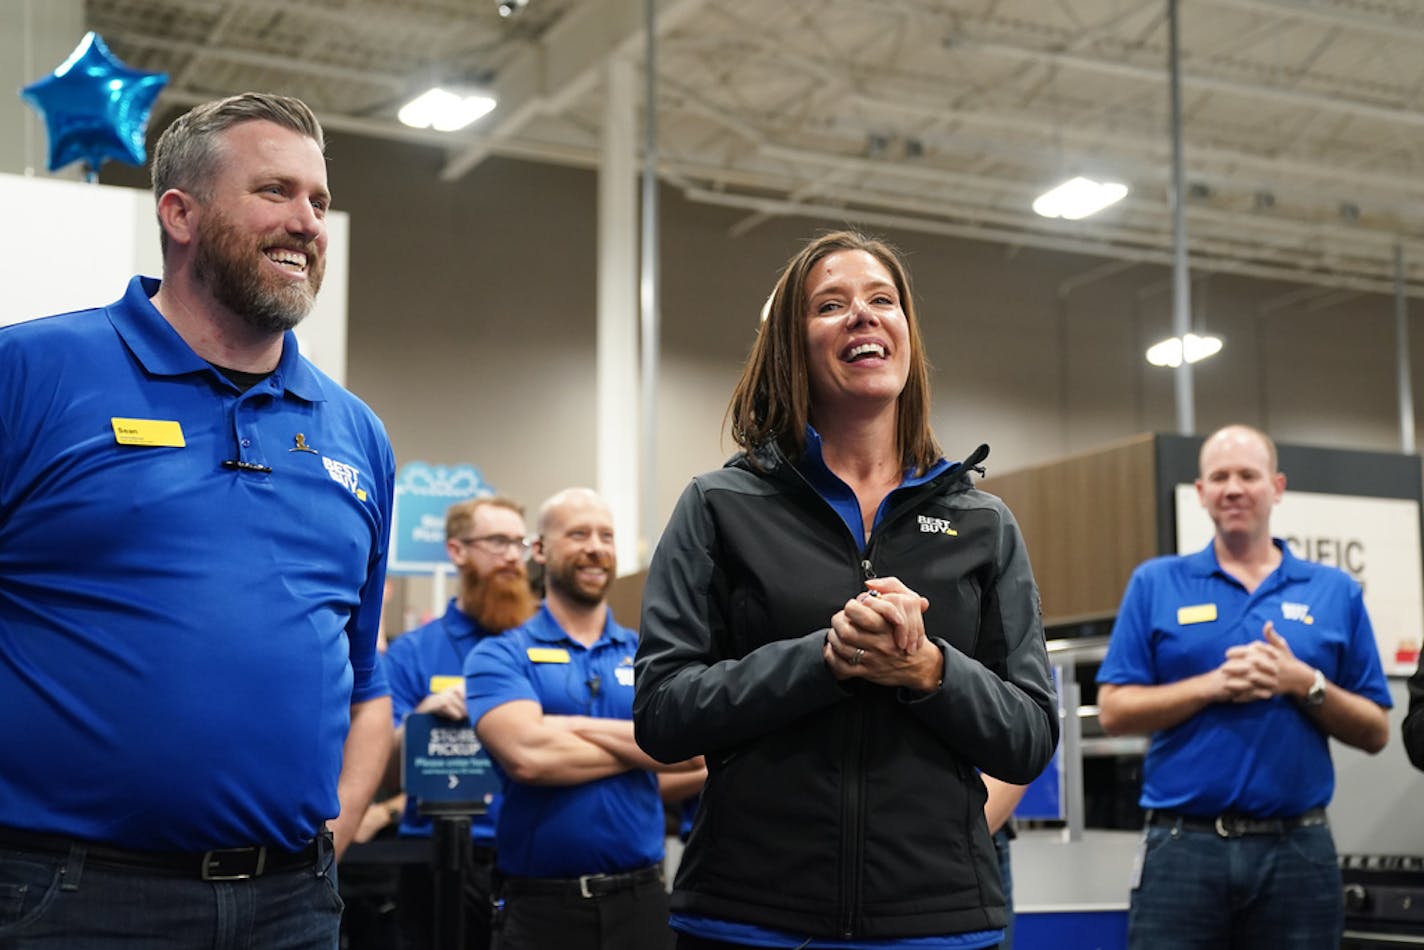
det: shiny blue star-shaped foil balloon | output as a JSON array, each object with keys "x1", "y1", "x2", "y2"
[{"x1": 20, "y1": 33, "x2": 168, "y2": 181}]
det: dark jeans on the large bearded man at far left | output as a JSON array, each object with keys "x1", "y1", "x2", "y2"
[{"x1": 0, "y1": 846, "x2": 342, "y2": 950}]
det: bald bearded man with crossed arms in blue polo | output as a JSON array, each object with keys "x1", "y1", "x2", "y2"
[{"x1": 464, "y1": 489, "x2": 706, "y2": 950}]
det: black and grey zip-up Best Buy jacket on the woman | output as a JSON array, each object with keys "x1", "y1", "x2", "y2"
[{"x1": 634, "y1": 447, "x2": 1058, "y2": 939}]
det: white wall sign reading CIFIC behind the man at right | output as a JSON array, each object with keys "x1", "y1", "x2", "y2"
[{"x1": 1176, "y1": 484, "x2": 1424, "y2": 675}]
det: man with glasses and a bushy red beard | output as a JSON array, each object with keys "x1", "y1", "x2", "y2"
[{"x1": 384, "y1": 497, "x2": 538, "y2": 950}]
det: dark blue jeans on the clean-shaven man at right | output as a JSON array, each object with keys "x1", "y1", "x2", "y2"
[{"x1": 1128, "y1": 825, "x2": 1344, "y2": 950}]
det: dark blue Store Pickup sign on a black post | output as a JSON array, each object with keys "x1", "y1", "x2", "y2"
[{"x1": 402, "y1": 712, "x2": 500, "y2": 810}]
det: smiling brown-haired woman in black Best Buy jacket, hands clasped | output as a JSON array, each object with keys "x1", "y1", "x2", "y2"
[{"x1": 634, "y1": 232, "x2": 1058, "y2": 950}]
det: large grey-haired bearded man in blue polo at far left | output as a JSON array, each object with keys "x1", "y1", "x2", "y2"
[{"x1": 0, "y1": 94, "x2": 394, "y2": 950}]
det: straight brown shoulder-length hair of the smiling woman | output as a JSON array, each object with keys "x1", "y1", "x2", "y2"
[{"x1": 726, "y1": 231, "x2": 940, "y2": 474}]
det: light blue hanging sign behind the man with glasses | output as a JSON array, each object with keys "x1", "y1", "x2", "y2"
[{"x1": 389, "y1": 461, "x2": 494, "y2": 574}]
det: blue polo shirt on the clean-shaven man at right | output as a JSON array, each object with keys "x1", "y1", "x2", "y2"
[{"x1": 1098, "y1": 538, "x2": 1393, "y2": 818}]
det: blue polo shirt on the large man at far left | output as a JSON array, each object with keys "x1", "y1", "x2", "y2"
[{"x1": 0, "y1": 278, "x2": 394, "y2": 852}]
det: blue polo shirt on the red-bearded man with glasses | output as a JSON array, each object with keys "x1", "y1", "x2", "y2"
[{"x1": 383, "y1": 597, "x2": 500, "y2": 846}]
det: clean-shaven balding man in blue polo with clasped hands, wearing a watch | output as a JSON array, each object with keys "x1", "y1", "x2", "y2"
[{"x1": 1098, "y1": 426, "x2": 1391, "y2": 950}]
